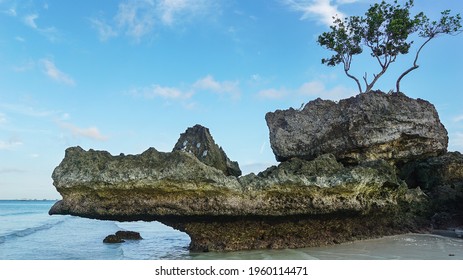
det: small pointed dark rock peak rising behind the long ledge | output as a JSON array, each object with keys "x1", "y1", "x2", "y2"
[{"x1": 173, "y1": 125, "x2": 241, "y2": 177}]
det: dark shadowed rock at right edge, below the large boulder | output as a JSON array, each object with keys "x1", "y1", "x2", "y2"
[{"x1": 400, "y1": 152, "x2": 463, "y2": 229}]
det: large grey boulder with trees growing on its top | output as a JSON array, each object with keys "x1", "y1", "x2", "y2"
[{"x1": 265, "y1": 92, "x2": 448, "y2": 164}]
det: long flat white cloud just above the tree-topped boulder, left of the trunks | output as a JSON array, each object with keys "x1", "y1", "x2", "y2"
[{"x1": 257, "y1": 81, "x2": 356, "y2": 100}]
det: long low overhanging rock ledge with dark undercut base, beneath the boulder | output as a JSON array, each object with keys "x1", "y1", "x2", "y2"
[{"x1": 50, "y1": 147, "x2": 426, "y2": 251}]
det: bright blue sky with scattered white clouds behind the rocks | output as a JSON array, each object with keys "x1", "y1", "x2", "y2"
[{"x1": 0, "y1": 0, "x2": 463, "y2": 199}]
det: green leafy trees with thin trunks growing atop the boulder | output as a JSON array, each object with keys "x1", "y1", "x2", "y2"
[{"x1": 317, "y1": 0, "x2": 462, "y2": 93}]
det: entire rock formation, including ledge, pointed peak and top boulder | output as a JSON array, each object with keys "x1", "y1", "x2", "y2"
[{"x1": 50, "y1": 93, "x2": 463, "y2": 251}]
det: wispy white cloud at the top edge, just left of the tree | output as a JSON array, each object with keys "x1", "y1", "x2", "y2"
[{"x1": 282, "y1": 0, "x2": 358, "y2": 26}]
